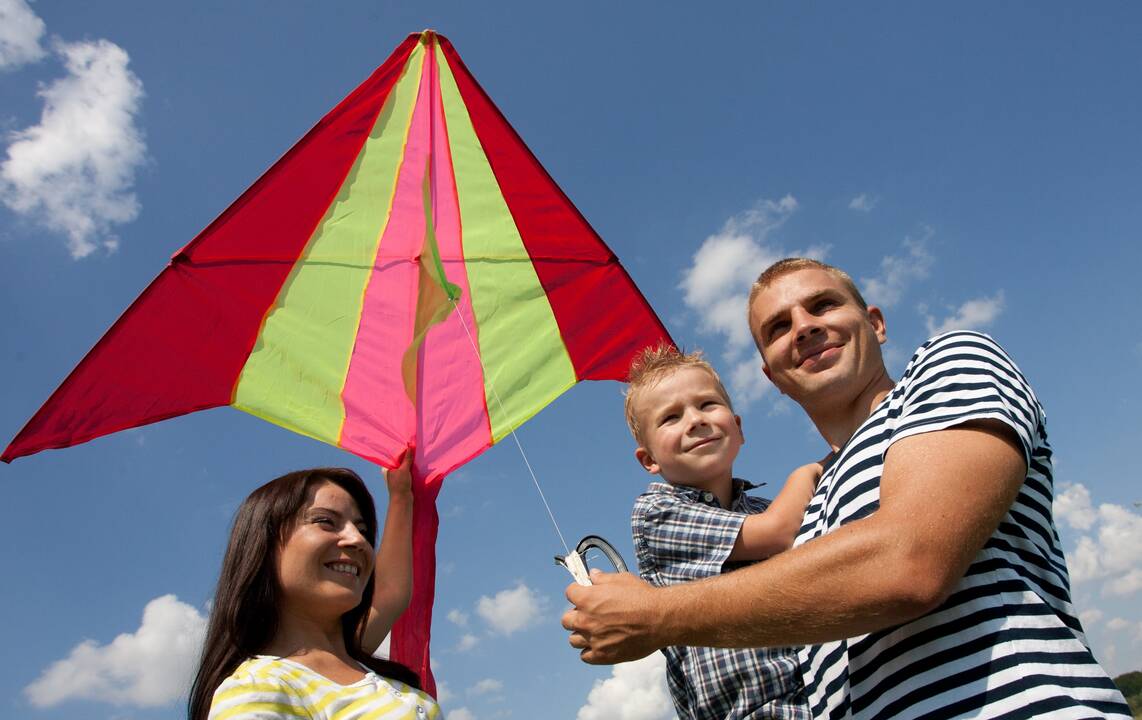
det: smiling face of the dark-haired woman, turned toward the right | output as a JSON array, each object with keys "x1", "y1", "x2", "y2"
[{"x1": 278, "y1": 481, "x2": 373, "y2": 617}]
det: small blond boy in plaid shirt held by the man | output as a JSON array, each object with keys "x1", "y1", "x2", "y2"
[{"x1": 626, "y1": 346, "x2": 821, "y2": 720}]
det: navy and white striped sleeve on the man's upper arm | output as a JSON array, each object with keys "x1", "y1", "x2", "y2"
[{"x1": 885, "y1": 331, "x2": 1043, "y2": 463}]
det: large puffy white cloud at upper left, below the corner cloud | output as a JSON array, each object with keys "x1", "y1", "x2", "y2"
[{"x1": 0, "y1": 40, "x2": 146, "y2": 258}]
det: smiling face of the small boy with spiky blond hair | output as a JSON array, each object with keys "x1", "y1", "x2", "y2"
[{"x1": 635, "y1": 367, "x2": 745, "y2": 489}]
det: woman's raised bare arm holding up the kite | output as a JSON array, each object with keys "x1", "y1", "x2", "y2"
[{"x1": 361, "y1": 448, "x2": 412, "y2": 654}]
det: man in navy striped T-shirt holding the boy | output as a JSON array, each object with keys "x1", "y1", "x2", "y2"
[{"x1": 563, "y1": 258, "x2": 1129, "y2": 718}]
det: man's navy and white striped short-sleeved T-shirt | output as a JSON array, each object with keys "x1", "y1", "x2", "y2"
[{"x1": 795, "y1": 331, "x2": 1131, "y2": 719}]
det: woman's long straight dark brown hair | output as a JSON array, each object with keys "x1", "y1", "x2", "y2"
[{"x1": 187, "y1": 467, "x2": 420, "y2": 720}]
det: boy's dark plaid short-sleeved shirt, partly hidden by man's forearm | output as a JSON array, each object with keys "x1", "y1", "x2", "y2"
[{"x1": 630, "y1": 480, "x2": 810, "y2": 720}]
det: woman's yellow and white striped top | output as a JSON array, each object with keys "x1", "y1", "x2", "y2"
[{"x1": 210, "y1": 655, "x2": 443, "y2": 720}]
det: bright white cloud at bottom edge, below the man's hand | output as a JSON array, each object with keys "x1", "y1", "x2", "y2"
[{"x1": 576, "y1": 653, "x2": 675, "y2": 720}]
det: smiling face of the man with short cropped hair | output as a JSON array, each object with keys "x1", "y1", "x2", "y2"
[{"x1": 749, "y1": 267, "x2": 887, "y2": 409}]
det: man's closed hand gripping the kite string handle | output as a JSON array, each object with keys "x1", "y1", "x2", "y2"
[{"x1": 563, "y1": 569, "x2": 668, "y2": 665}]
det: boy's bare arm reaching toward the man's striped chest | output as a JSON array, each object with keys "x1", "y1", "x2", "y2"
[{"x1": 729, "y1": 463, "x2": 822, "y2": 561}]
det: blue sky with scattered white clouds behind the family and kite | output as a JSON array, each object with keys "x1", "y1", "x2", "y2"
[{"x1": 0, "y1": 0, "x2": 1142, "y2": 720}]
